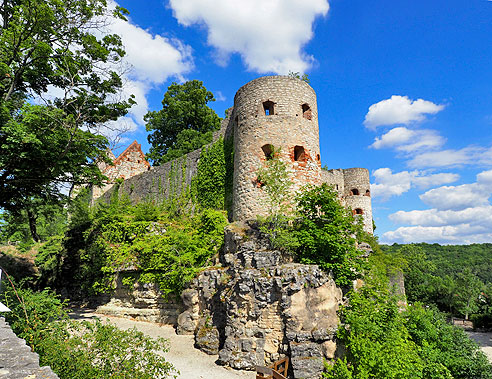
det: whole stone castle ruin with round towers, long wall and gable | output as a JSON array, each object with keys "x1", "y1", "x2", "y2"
[{"x1": 93, "y1": 76, "x2": 373, "y2": 233}]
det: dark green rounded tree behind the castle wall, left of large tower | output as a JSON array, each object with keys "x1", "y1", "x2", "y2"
[{"x1": 145, "y1": 80, "x2": 220, "y2": 165}]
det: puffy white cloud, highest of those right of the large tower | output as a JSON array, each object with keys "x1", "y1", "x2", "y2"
[{"x1": 364, "y1": 95, "x2": 444, "y2": 129}]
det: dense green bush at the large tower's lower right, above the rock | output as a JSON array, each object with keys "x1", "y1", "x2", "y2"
[{"x1": 297, "y1": 184, "x2": 364, "y2": 286}]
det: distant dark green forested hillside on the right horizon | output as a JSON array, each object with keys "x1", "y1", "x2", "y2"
[{"x1": 381, "y1": 243, "x2": 492, "y2": 328}]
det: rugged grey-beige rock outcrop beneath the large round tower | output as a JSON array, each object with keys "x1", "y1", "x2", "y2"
[{"x1": 177, "y1": 229, "x2": 342, "y2": 378}]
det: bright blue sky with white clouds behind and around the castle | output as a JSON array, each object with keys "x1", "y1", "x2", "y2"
[{"x1": 99, "y1": 0, "x2": 492, "y2": 244}]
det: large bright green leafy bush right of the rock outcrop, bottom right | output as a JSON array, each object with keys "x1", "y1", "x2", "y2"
[{"x1": 324, "y1": 257, "x2": 492, "y2": 379}]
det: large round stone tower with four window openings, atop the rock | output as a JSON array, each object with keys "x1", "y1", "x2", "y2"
[{"x1": 232, "y1": 76, "x2": 321, "y2": 220}]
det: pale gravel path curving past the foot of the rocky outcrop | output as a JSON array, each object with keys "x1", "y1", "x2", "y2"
[{"x1": 71, "y1": 310, "x2": 256, "y2": 379}]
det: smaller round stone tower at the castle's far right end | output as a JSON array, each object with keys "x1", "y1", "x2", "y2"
[{"x1": 343, "y1": 167, "x2": 373, "y2": 234}]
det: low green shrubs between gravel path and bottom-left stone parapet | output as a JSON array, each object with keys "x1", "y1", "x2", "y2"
[{"x1": 2, "y1": 288, "x2": 176, "y2": 379}]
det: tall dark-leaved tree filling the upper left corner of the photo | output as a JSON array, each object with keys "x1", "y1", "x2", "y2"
[{"x1": 0, "y1": 0, "x2": 134, "y2": 240}]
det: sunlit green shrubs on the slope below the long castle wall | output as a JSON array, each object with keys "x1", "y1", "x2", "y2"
[{"x1": 99, "y1": 209, "x2": 230, "y2": 295}]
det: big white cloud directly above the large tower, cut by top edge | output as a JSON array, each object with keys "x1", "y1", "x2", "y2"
[{"x1": 169, "y1": 0, "x2": 329, "y2": 74}]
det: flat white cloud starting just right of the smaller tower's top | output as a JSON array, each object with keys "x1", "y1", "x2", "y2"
[{"x1": 371, "y1": 167, "x2": 459, "y2": 200}]
